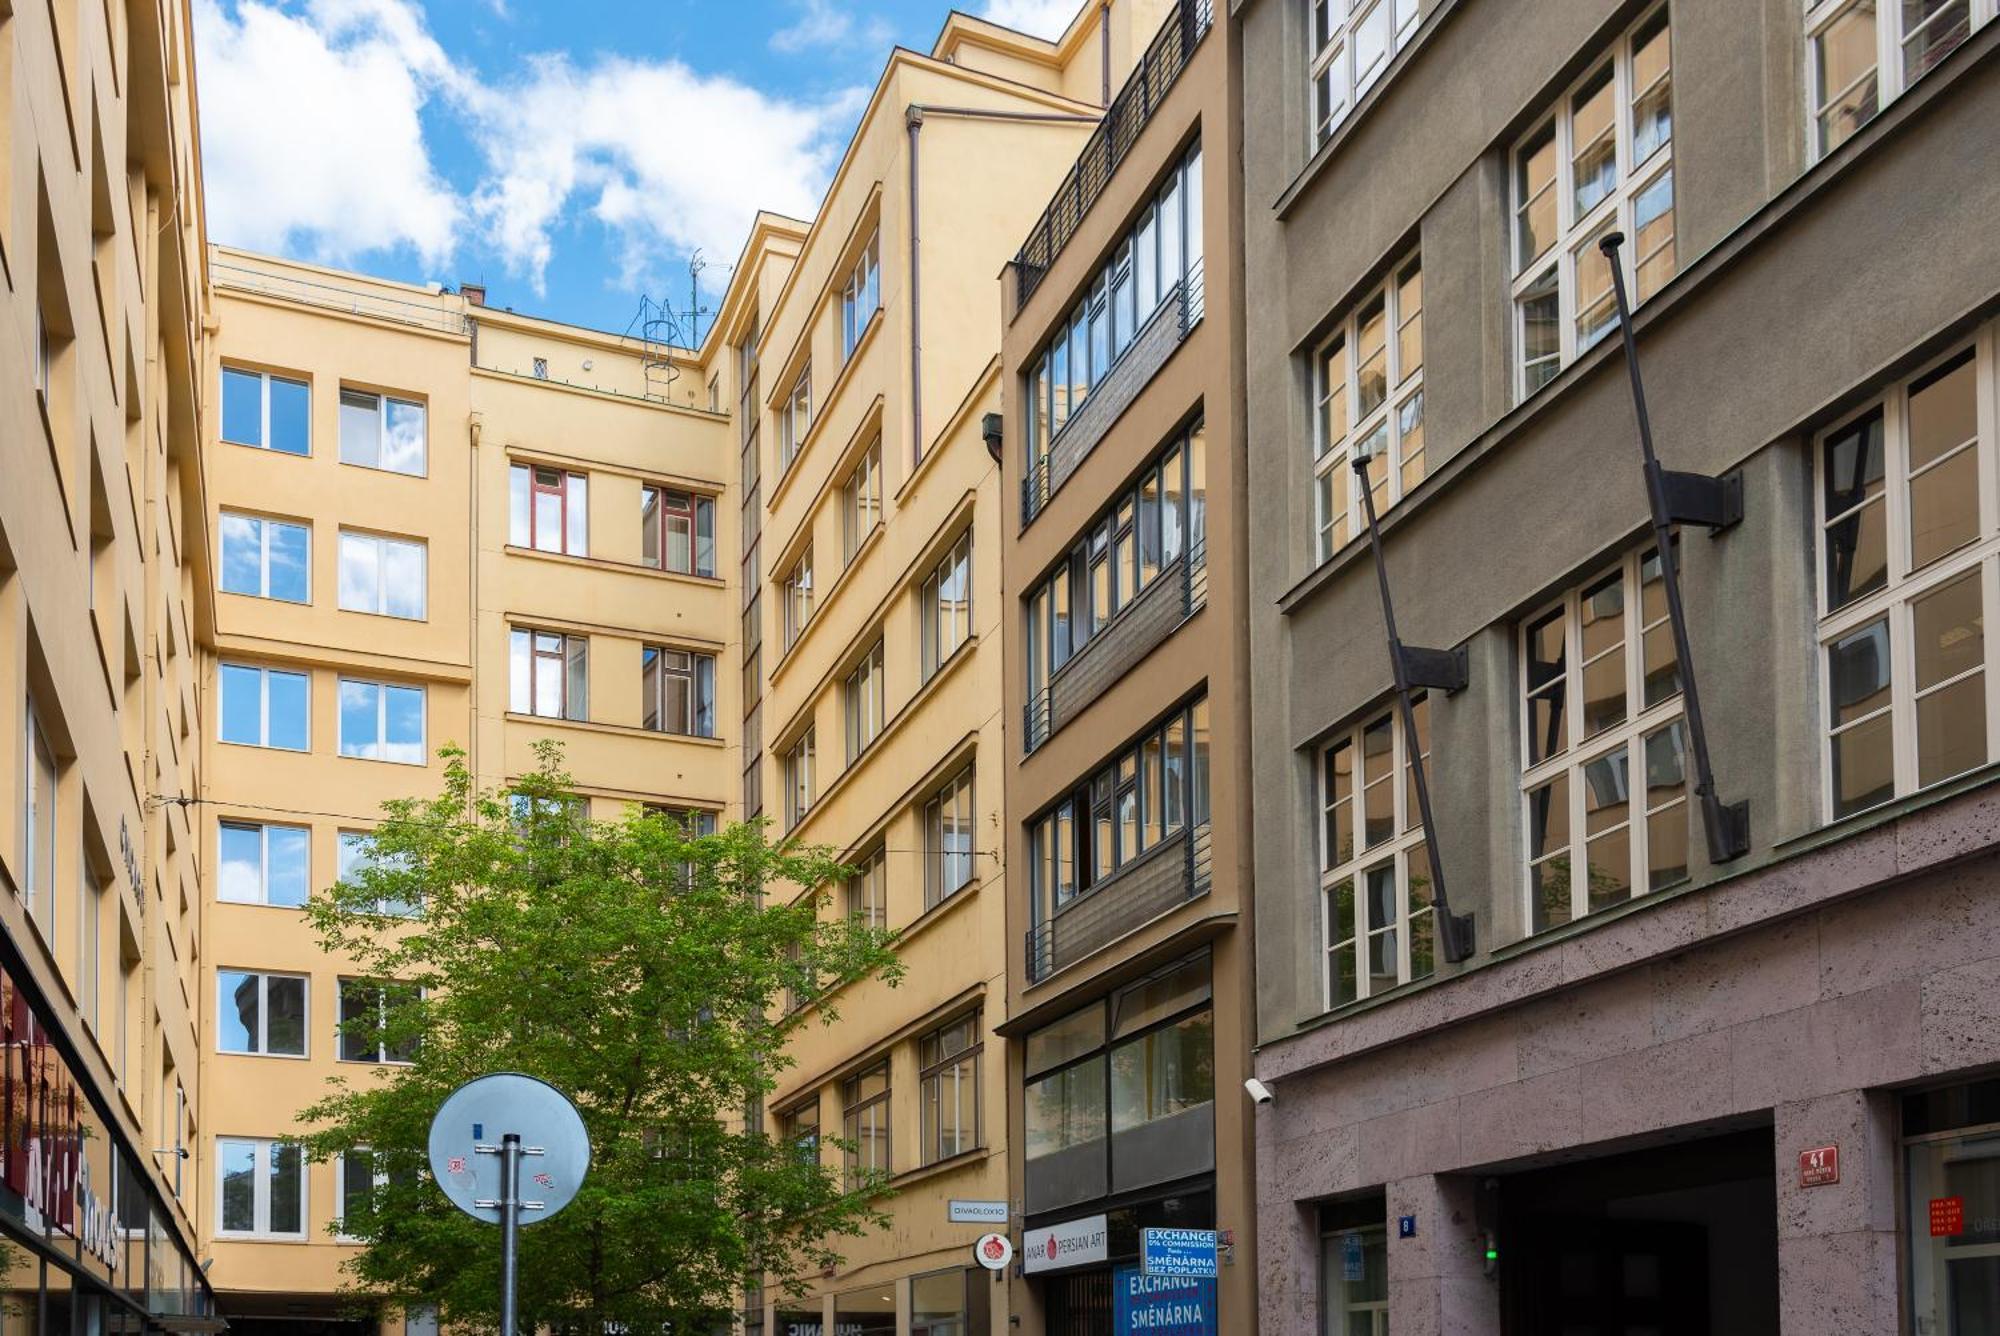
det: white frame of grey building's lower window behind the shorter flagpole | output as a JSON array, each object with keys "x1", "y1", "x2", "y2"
[{"x1": 1314, "y1": 694, "x2": 1438, "y2": 1010}]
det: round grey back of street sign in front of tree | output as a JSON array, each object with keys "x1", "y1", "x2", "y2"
[{"x1": 430, "y1": 1072, "x2": 590, "y2": 1224}]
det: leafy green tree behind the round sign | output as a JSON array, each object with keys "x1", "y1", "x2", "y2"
[{"x1": 300, "y1": 744, "x2": 898, "y2": 1336}]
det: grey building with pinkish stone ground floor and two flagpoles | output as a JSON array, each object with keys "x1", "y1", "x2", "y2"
[{"x1": 1236, "y1": 0, "x2": 2000, "y2": 1336}]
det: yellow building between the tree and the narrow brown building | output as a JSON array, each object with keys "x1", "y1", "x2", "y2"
[{"x1": 710, "y1": 2, "x2": 1162, "y2": 1336}]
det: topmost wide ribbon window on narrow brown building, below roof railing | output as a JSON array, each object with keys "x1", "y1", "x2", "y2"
[{"x1": 1026, "y1": 144, "x2": 1202, "y2": 474}]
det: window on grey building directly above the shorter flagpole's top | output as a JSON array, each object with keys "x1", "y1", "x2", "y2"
[{"x1": 1312, "y1": 256, "x2": 1428, "y2": 562}]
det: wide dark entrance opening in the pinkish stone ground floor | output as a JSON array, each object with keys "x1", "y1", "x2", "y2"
[{"x1": 1496, "y1": 1128, "x2": 1778, "y2": 1336}]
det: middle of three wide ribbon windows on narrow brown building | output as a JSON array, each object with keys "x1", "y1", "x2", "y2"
[{"x1": 1026, "y1": 422, "x2": 1208, "y2": 698}]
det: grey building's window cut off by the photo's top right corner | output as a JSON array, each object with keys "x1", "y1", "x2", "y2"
[{"x1": 1806, "y1": 0, "x2": 1996, "y2": 156}]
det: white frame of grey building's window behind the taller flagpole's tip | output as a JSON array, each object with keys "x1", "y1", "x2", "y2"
[{"x1": 1506, "y1": 4, "x2": 1680, "y2": 402}]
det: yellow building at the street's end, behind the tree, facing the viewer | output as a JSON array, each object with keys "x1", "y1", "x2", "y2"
[{"x1": 196, "y1": 248, "x2": 740, "y2": 1336}]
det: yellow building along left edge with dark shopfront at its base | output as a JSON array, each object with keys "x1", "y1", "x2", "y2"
[{"x1": 0, "y1": 0, "x2": 214, "y2": 1336}]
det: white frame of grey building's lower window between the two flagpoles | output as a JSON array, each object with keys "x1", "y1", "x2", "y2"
[{"x1": 1516, "y1": 542, "x2": 1694, "y2": 934}]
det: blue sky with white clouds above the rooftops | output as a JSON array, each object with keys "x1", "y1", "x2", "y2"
[{"x1": 194, "y1": 0, "x2": 1082, "y2": 332}]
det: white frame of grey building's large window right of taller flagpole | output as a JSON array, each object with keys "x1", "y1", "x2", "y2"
[{"x1": 1812, "y1": 322, "x2": 2000, "y2": 820}]
